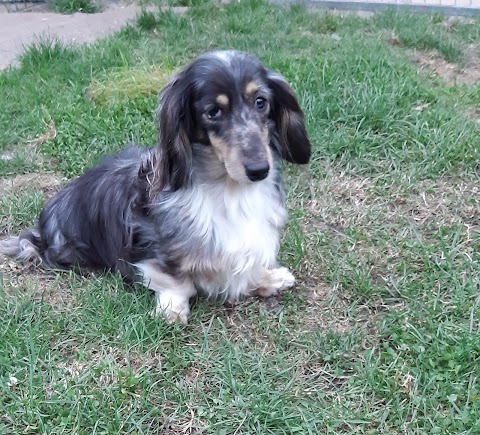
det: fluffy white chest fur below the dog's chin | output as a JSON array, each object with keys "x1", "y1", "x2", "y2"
[{"x1": 179, "y1": 177, "x2": 286, "y2": 299}]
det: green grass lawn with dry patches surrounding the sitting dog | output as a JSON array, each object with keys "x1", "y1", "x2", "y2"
[{"x1": 0, "y1": 0, "x2": 480, "y2": 434}]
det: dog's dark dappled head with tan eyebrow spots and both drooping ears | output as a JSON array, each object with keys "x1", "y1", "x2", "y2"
[{"x1": 154, "y1": 51, "x2": 311, "y2": 190}]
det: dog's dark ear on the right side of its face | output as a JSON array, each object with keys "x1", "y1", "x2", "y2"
[{"x1": 267, "y1": 71, "x2": 311, "y2": 164}]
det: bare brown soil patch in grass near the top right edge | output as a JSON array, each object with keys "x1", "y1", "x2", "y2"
[{"x1": 412, "y1": 44, "x2": 480, "y2": 86}]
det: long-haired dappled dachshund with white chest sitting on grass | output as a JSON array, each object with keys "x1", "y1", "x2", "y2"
[{"x1": 0, "y1": 50, "x2": 311, "y2": 323}]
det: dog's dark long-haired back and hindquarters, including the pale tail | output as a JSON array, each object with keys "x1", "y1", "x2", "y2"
[{"x1": 0, "y1": 146, "x2": 151, "y2": 275}]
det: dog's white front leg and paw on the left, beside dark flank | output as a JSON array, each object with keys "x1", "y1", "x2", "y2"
[{"x1": 134, "y1": 261, "x2": 197, "y2": 324}]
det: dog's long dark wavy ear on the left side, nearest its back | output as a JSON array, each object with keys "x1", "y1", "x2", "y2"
[{"x1": 152, "y1": 71, "x2": 193, "y2": 192}]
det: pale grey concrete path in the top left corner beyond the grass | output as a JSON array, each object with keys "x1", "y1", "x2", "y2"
[{"x1": 0, "y1": 4, "x2": 161, "y2": 70}]
